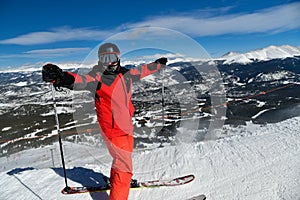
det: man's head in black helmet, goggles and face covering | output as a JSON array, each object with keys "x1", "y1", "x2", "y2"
[{"x1": 98, "y1": 43, "x2": 120, "y2": 71}]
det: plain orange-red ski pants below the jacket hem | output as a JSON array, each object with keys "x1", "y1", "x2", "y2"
[{"x1": 106, "y1": 135, "x2": 134, "y2": 200}]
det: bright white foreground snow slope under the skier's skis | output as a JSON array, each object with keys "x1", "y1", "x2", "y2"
[{"x1": 0, "y1": 117, "x2": 300, "y2": 200}]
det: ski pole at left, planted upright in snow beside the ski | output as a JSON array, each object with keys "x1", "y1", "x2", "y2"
[{"x1": 52, "y1": 85, "x2": 69, "y2": 189}]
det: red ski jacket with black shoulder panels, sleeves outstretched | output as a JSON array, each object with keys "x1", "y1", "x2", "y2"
[{"x1": 67, "y1": 63, "x2": 161, "y2": 138}]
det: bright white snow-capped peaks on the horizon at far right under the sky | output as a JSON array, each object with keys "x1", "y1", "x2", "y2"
[{"x1": 217, "y1": 45, "x2": 300, "y2": 64}]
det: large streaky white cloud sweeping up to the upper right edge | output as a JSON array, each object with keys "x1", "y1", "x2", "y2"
[{"x1": 127, "y1": 2, "x2": 300, "y2": 37}]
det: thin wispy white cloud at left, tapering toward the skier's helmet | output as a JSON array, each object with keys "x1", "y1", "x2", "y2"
[{"x1": 0, "y1": 27, "x2": 111, "y2": 45}]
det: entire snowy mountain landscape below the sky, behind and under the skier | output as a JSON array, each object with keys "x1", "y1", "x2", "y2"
[{"x1": 0, "y1": 46, "x2": 300, "y2": 200}]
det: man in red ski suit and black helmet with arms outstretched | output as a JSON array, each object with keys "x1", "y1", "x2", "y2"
[{"x1": 42, "y1": 43, "x2": 167, "y2": 200}]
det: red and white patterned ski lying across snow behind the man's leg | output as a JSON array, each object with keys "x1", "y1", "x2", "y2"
[{"x1": 61, "y1": 174, "x2": 195, "y2": 194}]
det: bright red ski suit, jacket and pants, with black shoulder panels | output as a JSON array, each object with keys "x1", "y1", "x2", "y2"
[{"x1": 68, "y1": 63, "x2": 161, "y2": 200}]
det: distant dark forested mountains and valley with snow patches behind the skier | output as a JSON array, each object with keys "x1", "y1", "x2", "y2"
[{"x1": 0, "y1": 45, "x2": 300, "y2": 157}]
